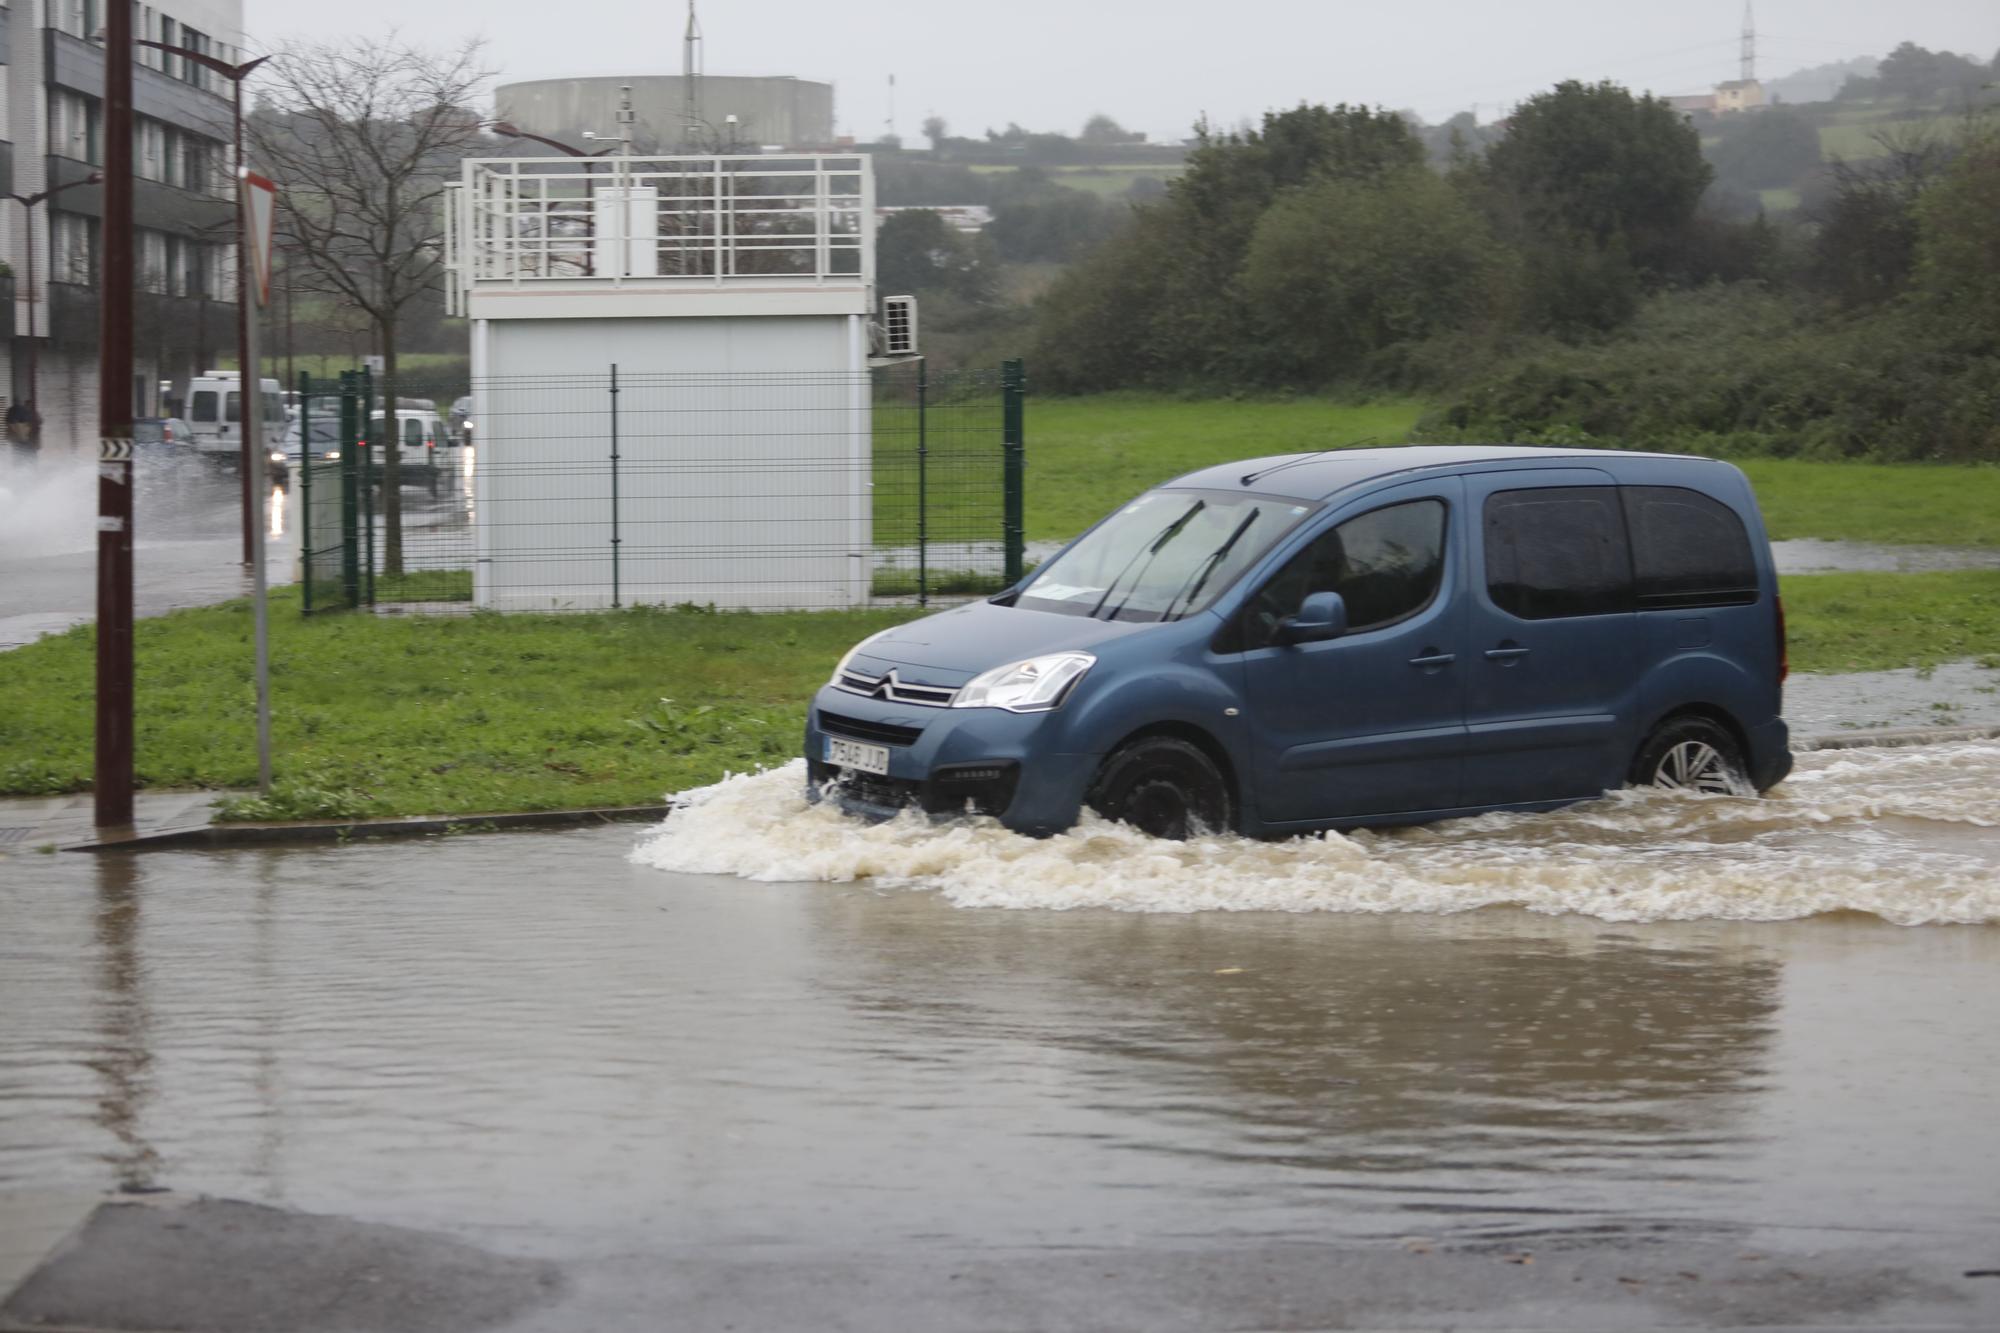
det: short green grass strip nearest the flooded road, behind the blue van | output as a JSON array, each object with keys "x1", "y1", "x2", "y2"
[{"x1": 0, "y1": 570, "x2": 2000, "y2": 819}]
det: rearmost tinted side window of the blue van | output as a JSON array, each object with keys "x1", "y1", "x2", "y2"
[{"x1": 1620, "y1": 486, "x2": 1758, "y2": 610}]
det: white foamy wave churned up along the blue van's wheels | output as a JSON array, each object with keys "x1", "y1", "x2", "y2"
[{"x1": 632, "y1": 743, "x2": 2000, "y2": 925}]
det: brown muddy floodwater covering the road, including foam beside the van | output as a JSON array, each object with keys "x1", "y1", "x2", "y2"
[{"x1": 0, "y1": 745, "x2": 2000, "y2": 1255}]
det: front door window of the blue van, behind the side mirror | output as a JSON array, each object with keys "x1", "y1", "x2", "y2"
[{"x1": 1218, "y1": 500, "x2": 1444, "y2": 650}]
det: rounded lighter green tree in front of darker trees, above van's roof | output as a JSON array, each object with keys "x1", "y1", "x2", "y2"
[{"x1": 1242, "y1": 166, "x2": 1508, "y2": 384}]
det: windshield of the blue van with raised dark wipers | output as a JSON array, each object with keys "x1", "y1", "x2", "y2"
[{"x1": 1014, "y1": 490, "x2": 1312, "y2": 620}]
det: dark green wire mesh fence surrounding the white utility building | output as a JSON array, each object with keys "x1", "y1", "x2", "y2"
[{"x1": 292, "y1": 362, "x2": 1026, "y2": 612}]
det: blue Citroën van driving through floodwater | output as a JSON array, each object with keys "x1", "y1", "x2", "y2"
[{"x1": 806, "y1": 446, "x2": 1792, "y2": 839}]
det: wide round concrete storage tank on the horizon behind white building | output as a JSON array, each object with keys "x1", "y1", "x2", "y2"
[{"x1": 508, "y1": 74, "x2": 834, "y2": 152}]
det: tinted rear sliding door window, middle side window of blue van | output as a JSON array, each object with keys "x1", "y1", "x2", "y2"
[{"x1": 1486, "y1": 486, "x2": 1632, "y2": 620}]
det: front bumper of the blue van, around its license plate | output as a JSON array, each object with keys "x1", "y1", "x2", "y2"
[{"x1": 806, "y1": 685, "x2": 1102, "y2": 837}]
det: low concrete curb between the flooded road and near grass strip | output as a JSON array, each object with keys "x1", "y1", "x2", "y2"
[{"x1": 47, "y1": 727, "x2": 2000, "y2": 853}]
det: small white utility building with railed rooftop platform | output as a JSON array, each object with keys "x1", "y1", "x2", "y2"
[{"x1": 446, "y1": 154, "x2": 874, "y2": 610}]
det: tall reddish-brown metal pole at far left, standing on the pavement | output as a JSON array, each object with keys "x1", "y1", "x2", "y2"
[{"x1": 94, "y1": 2, "x2": 132, "y2": 827}]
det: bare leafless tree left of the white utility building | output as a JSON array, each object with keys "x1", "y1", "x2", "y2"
[{"x1": 244, "y1": 34, "x2": 490, "y2": 574}]
